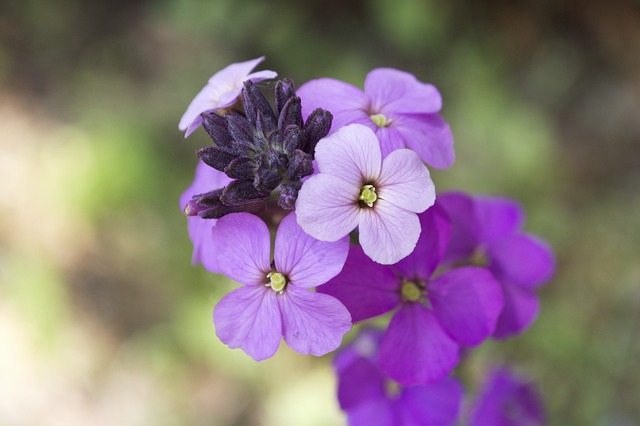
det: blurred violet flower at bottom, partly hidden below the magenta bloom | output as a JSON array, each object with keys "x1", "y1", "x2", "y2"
[{"x1": 334, "y1": 329, "x2": 462, "y2": 426}]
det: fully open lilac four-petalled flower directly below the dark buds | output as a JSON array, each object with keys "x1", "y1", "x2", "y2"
[{"x1": 211, "y1": 213, "x2": 351, "y2": 361}]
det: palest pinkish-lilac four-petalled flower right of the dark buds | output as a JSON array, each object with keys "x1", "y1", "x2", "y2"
[{"x1": 296, "y1": 124, "x2": 435, "y2": 264}]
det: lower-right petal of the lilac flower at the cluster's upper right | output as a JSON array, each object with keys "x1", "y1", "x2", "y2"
[{"x1": 391, "y1": 114, "x2": 456, "y2": 169}]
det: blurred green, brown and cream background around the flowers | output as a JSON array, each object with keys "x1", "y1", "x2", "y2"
[{"x1": 0, "y1": 0, "x2": 640, "y2": 426}]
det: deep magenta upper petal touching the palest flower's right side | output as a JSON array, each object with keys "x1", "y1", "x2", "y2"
[{"x1": 391, "y1": 206, "x2": 451, "y2": 281}]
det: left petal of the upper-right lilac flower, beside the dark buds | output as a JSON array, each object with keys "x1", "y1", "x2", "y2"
[{"x1": 296, "y1": 78, "x2": 371, "y2": 132}]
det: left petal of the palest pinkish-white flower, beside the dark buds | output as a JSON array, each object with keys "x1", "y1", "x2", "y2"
[{"x1": 296, "y1": 173, "x2": 360, "y2": 241}]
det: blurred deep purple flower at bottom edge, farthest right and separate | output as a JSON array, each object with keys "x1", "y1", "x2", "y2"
[{"x1": 469, "y1": 369, "x2": 544, "y2": 426}]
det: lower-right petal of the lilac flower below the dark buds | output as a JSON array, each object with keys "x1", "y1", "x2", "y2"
[{"x1": 278, "y1": 285, "x2": 351, "y2": 356}]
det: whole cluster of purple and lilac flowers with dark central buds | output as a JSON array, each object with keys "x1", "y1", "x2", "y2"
[{"x1": 179, "y1": 58, "x2": 555, "y2": 426}]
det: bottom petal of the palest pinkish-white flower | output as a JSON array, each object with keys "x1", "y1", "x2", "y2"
[{"x1": 359, "y1": 199, "x2": 420, "y2": 265}]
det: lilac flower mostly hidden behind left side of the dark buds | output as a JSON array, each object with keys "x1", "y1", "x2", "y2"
[{"x1": 180, "y1": 161, "x2": 231, "y2": 273}]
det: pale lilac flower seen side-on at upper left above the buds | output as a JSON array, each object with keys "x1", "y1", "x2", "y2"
[{"x1": 178, "y1": 56, "x2": 278, "y2": 138}]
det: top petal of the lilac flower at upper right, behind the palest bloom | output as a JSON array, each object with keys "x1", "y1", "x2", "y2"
[{"x1": 364, "y1": 68, "x2": 442, "y2": 114}]
